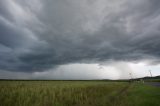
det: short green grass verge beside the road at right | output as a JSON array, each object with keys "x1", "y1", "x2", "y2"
[{"x1": 125, "y1": 84, "x2": 160, "y2": 106}]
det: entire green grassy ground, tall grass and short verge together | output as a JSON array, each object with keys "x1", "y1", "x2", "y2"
[{"x1": 0, "y1": 81, "x2": 160, "y2": 106}]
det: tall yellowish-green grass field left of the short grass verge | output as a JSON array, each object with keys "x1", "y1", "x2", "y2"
[{"x1": 0, "y1": 81, "x2": 126, "y2": 106}]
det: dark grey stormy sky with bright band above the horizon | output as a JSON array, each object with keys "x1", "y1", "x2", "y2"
[{"x1": 0, "y1": 0, "x2": 160, "y2": 79}]
